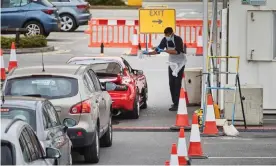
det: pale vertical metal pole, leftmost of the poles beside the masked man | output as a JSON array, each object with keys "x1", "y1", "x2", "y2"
[{"x1": 201, "y1": 0, "x2": 208, "y2": 109}]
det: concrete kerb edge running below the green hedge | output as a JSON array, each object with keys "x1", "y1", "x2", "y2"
[{"x1": 3, "y1": 46, "x2": 55, "y2": 54}]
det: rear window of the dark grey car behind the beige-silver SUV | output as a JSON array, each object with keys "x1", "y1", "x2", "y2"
[{"x1": 1, "y1": 106, "x2": 36, "y2": 131}]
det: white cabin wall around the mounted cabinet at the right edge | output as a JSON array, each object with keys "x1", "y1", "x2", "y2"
[{"x1": 229, "y1": 0, "x2": 276, "y2": 113}]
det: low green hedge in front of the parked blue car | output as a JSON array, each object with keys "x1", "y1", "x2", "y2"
[{"x1": 1, "y1": 35, "x2": 47, "y2": 49}]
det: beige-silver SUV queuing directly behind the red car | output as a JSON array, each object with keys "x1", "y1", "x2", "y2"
[{"x1": 3, "y1": 64, "x2": 113, "y2": 163}]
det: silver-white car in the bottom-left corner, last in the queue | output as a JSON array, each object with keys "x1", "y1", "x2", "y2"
[{"x1": 1, "y1": 119, "x2": 61, "y2": 165}]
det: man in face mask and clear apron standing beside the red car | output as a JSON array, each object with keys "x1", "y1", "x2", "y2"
[{"x1": 143, "y1": 27, "x2": 187, "y2": 111}]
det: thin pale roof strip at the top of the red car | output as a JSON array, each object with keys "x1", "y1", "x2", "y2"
[{"x1": 67, "y1": 56, "x2": 125, "y2": 67}]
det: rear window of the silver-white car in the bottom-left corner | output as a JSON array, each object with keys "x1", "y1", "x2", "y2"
[{"x1": 0, "y1": 140, "x2": 16, "y2": 165}]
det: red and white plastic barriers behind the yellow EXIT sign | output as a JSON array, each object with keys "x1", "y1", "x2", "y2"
[{"x1": 85, "y1": 18, "x2": 220, "y2": 53}]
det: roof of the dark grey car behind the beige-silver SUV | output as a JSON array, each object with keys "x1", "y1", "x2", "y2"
[{"x1": 1, "y1": 96, "x2": 44, "y2": 110}]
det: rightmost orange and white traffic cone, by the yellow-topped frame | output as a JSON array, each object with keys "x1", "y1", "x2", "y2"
[{"x1": 202, "y1": 94, "x2": 219, "y2": 136}]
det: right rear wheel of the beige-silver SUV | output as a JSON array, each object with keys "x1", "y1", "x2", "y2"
[{"x1": 84, "y1": 126, "x2": 100, "y2": 163}]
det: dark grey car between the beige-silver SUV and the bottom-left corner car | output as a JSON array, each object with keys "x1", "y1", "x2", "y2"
[{"x1": 1, "y1": 96, "x2": 73, "y2": 165}]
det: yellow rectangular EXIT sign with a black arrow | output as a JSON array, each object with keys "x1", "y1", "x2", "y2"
[{"x1": 139, "y1": 8, "x2": 176, "y2": 34}]
